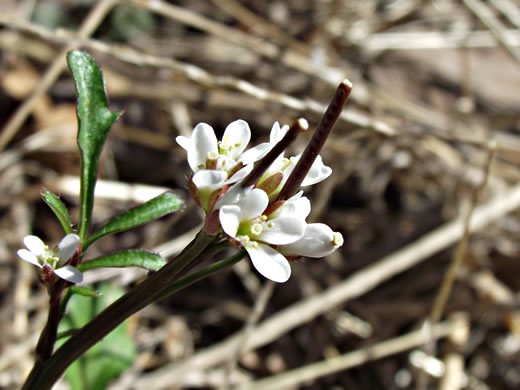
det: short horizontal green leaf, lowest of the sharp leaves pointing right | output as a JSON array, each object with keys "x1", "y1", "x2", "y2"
[{"x1": 77, "y1": 250, "x2": 166, "y2": 272}]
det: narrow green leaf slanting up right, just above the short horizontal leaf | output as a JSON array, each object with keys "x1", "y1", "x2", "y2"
[{"x1": 83, "y1": 192, "x2": 183, "y2": 249}]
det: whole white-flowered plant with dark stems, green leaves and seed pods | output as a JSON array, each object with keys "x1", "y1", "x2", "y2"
[{"x1": 18, "y1": 51, "x2": 352, "y2": 390}]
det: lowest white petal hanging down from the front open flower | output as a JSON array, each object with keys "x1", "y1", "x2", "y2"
[{"x1": 246, "y1": 244, "x2": 291, "y2": 283}]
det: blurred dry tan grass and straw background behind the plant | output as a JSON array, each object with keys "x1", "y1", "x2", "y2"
[{"x1": 0, "y1": 0, "x2": 520, "y2": 390}]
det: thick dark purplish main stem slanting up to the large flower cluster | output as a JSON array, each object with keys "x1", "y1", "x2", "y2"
[{"x1": 22, "y1": 231, "x2": 217, "y2": 390}]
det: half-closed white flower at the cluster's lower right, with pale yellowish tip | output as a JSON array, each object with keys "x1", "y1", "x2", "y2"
[{"x1": 279, "y1": 223, "x2": 343, "y2": 257}]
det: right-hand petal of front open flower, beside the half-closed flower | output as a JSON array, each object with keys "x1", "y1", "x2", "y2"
[{"x1": 258, "y1": 217, "x2": 307, "y2": 245}]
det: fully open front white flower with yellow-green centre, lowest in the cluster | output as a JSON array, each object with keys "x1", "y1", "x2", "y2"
[{"x1": 219, "y1": 188, "x2": 310, "y2": 283}]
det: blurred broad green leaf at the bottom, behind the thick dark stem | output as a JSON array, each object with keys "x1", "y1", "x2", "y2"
[{"x1": 58, "y1": 285, "x2": 136, "y2": 390}]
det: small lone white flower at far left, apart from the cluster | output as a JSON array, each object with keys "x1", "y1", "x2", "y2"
[{"x1": 16, "y1": 234, "x2": 83, "y2": 283}]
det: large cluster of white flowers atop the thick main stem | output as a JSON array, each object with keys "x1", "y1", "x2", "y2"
[{"x1": 176, "y1": 119, "x2": 343, "y2": 282}]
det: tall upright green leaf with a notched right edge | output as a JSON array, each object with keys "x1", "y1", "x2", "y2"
[{"x1": 67, "y1": 50, "x2": 119, "y2": 242}]
